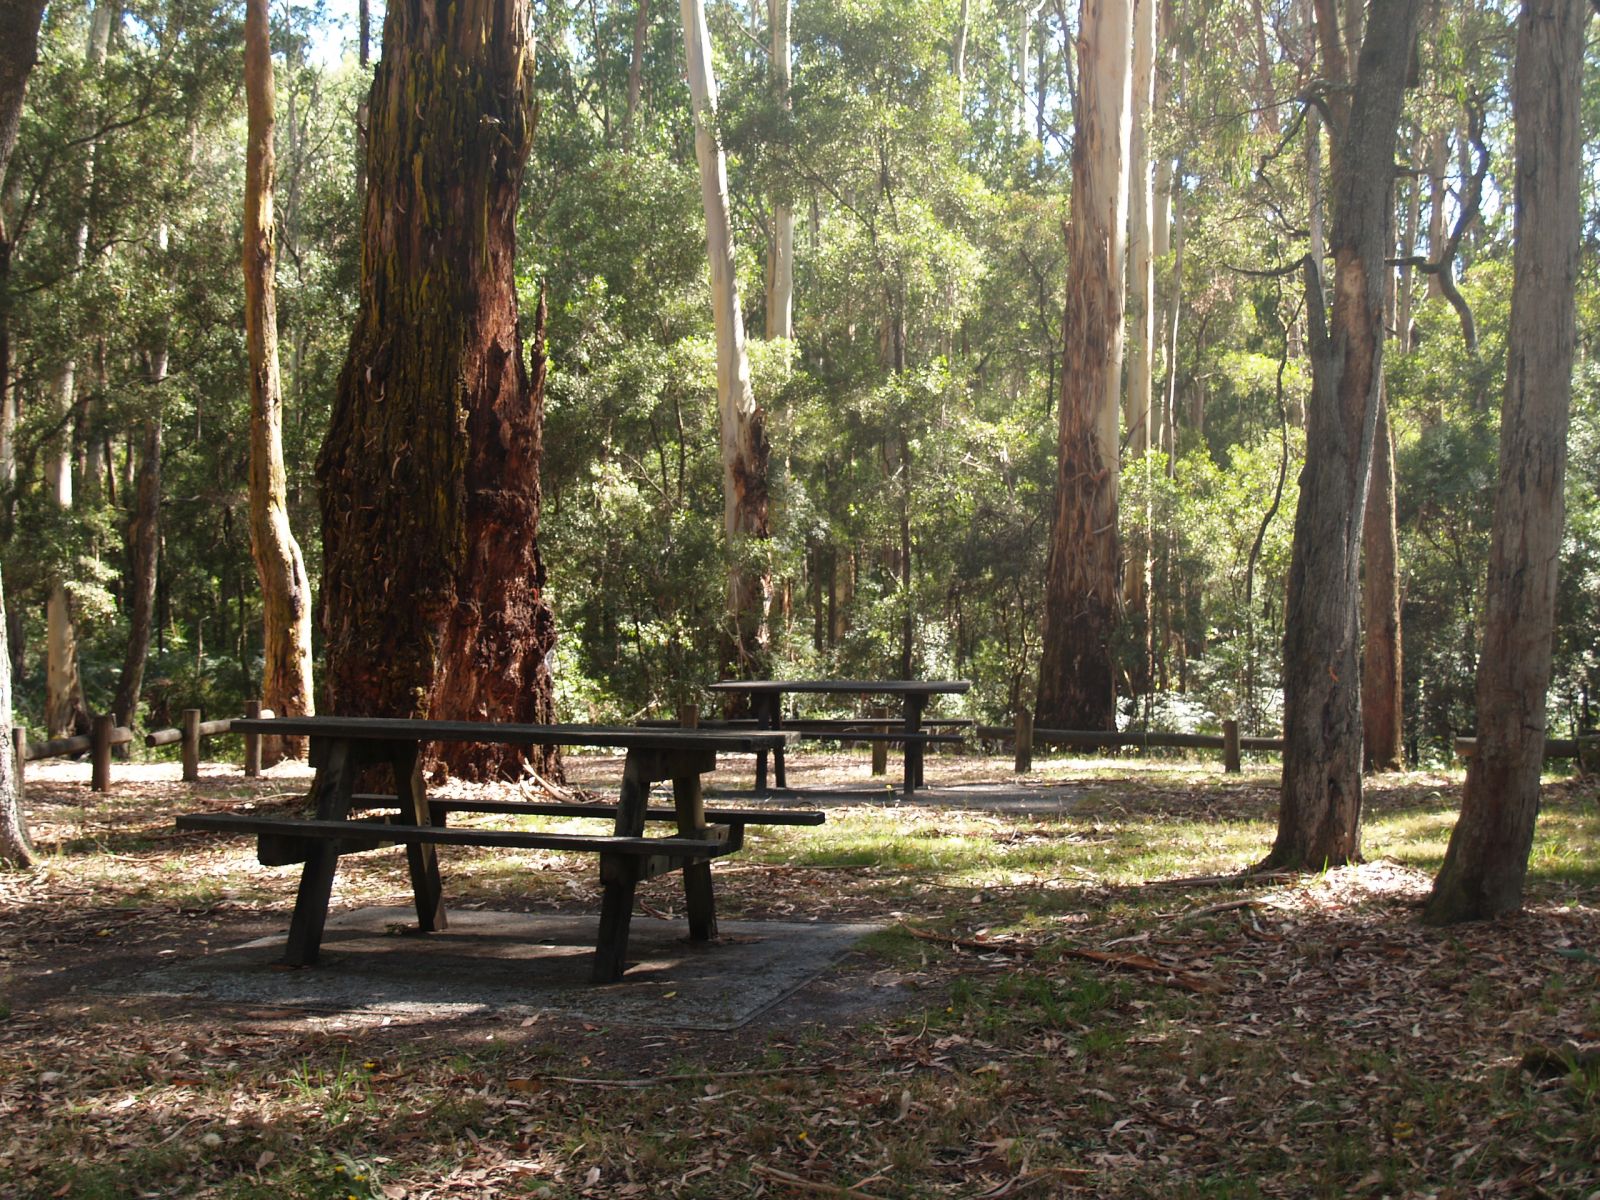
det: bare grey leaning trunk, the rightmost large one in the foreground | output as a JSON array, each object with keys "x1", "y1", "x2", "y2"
[{"x1": 1424, "y1": 0, "x2": 1589, "y2": 925}]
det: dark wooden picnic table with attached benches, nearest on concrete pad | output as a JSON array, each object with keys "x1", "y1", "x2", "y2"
[{"x1": 178, "y1": 717, "x2": 812, "y2": 982}]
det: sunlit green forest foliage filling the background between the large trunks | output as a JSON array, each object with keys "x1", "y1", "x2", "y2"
[{"x1": 0, "y1": 0, "x2": 1600, "y2": 762}]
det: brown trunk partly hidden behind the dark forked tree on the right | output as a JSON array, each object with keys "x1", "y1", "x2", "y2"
[{"x1": 1362, "y1": 395, "x2": 1405, "y2": 771}]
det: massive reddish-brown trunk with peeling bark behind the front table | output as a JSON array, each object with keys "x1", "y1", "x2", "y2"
[{"x1": 317, "y1": 0, "x2": 558, "y2": 776}]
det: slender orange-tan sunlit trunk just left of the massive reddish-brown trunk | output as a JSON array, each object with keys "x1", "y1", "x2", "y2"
[{"x1": 243, "y1": 0, "x2": 315, "y2": 765}]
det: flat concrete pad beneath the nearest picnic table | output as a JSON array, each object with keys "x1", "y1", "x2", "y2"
[{"x1": 118, "y1": 907, "x2": 883, "y2": 1029}]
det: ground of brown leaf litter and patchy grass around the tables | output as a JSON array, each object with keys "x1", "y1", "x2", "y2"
[{"x1": 0, "y1": 755, "x2": 1600, "y2": 1200}]
